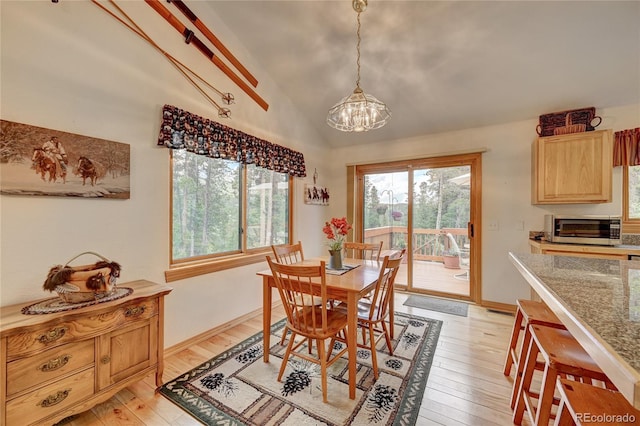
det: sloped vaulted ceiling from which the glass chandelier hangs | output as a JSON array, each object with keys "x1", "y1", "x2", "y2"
[{"x1": 202, "y1": 0, "x2": 640, "y2": 146}]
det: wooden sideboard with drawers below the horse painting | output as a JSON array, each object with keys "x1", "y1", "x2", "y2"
[{"x1": 0, "y1": 280, "x2": 172, "y2": 426}]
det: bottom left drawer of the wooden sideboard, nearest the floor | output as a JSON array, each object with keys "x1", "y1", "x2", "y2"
[{"x1": 6, "y1": 368, "x2": 95, "y2": 426}]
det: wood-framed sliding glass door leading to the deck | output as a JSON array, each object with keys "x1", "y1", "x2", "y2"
[{"x1": 355, "y1": 154, "x2": 480, "y2": 301}]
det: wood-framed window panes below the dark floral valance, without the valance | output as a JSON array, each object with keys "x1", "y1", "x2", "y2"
[{"x1": 171, "y1": 150, "x2": 292, "y2": 274}]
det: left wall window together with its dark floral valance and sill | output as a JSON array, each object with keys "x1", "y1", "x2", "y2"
[{"x1": 158, "y1": 105, "x2": 307, "y2": 282}]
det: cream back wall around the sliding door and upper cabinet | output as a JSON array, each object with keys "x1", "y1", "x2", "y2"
[{"x1": 333, "y1": 104, "x2": 640, "y2": 304}]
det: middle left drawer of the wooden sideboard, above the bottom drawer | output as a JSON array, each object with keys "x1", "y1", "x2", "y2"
[{"x1": 7, "y1": 339, "x2": 95, "y2": 398}]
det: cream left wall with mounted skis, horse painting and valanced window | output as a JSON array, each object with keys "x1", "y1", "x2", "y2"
[{"x1": 0, "y1": 0, "x2": 331, "y2": 346}]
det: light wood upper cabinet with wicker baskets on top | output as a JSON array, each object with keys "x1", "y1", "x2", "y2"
[{"x1": 531, "y1": 130, "x2": 613, "y2": 204}]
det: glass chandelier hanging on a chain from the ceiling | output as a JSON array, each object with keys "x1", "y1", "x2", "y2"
[{"x1": 327, "y1": 0, "x2": 391, "y2": 132}]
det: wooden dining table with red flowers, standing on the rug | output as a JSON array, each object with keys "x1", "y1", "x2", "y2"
[{"x1": 257, "y1": 257, "x2": 393, "y2": 399}]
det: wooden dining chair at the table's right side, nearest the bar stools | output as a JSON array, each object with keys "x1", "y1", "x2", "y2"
[{"x1": 336, "y1": 256, "x2": 402, "y2": 379}]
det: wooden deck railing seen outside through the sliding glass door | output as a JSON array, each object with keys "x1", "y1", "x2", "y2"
[{"x1": 364, "y1": 226, "x2": 469, "y2": 262}]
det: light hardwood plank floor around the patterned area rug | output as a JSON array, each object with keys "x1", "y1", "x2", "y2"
[{"x1": 56, "y1": 293, "x2": 528, "y2": 426}]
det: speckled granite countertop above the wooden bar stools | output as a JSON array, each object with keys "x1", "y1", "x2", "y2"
[{"x1": 509, "y1": 253, "x2": 640, "y2": 409}]
